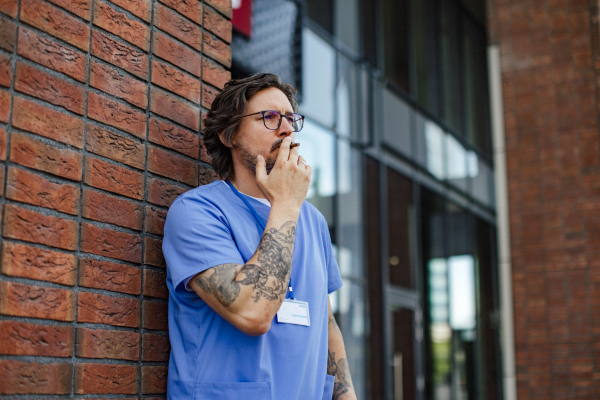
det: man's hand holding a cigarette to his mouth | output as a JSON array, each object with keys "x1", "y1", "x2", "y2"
[{"x1": 256, "y1": 136, "x2": 312, "y2": 212}]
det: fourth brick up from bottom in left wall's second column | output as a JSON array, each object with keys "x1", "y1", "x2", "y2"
[{"x1": 79, "y1": 258, "x2": 142, "y2": 295}]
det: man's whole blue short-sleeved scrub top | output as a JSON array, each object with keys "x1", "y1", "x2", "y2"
[{"x1": 163, "y1": 181, "x2": 342, "y2": 400}]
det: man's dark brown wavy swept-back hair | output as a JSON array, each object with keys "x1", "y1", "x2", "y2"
[{"x1": 203, "y1": 73, "x2": 298, "y2": 179}]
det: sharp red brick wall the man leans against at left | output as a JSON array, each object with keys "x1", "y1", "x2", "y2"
[{"x1": 0, "y1": 0, "x2": 231, "y2": 399}]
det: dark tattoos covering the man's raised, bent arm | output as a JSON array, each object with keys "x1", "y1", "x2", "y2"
[{"x1": 194, "y1": 222, "x2": 296, "y2": 307}]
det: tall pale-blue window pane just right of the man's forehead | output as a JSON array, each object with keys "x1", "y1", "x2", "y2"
[{"x1": 300, "y1": 28, "x2": 335, "y2": 127}]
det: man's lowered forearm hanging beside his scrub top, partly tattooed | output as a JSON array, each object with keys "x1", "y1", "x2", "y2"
[{"x1": 327, "y1": 311, "x2": 356, "y2": 400}]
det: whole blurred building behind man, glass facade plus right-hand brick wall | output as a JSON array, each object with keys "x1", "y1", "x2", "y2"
[{"x1": 231, "y1": 0, "x2": 600, "y2": 400}]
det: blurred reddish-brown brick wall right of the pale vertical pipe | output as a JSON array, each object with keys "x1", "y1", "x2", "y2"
[{"x1": 489, "y1": 0, "x2": 600, "y2": 400}]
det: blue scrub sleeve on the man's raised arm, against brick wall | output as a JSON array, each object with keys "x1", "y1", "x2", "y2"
[{"x1": 162, "y1": 192, "x2": 244, "y2": 296}]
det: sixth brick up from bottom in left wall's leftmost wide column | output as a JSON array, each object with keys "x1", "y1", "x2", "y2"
[{"x1": 6, "y1": 167, "x2": 79, "y2": 215}]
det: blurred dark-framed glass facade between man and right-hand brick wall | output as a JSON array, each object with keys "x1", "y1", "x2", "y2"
[{"x1": 232, "y1": 0, "x2": 504, "y2": 400}]
